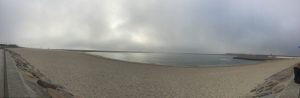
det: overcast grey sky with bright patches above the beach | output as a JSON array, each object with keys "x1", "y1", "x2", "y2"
[{"x1": 0, "y1": 0, "x2": 300, "y2": 55}]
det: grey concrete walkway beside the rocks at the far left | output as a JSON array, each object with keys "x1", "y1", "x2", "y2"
[{"x1": 0, "y1": 49, "x2": 36, "y2": 98}]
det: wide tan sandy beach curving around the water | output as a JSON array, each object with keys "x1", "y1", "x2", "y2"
[{"x1": 11, "y1": 48, "x2": 300, "y2": 98}]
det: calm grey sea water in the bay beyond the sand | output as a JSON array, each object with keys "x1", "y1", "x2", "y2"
[{"x1": 88, "y1": 52, "x2": 258, "y2": 67}]
